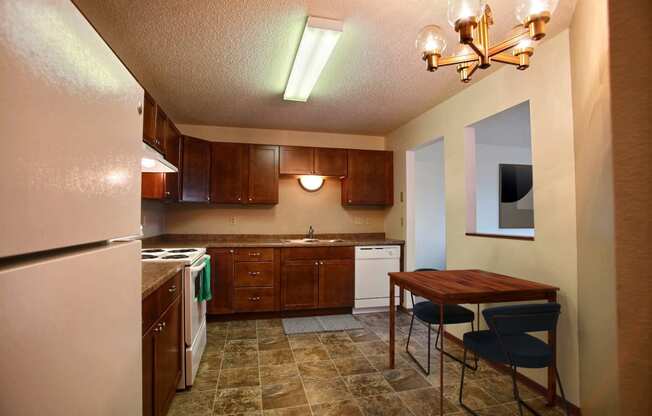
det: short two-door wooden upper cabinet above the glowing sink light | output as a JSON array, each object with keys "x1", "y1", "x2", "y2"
[{"x1": 279, "y1": 146, "x2": 347, "y2": 177}]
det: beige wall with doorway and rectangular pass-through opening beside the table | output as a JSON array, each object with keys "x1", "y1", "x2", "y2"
[{"x1": 385, "y1": 31, "x2": 579, "y2": 404}]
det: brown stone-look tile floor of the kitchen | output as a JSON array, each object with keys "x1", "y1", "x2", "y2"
[{"x1": 168, "y1": 313, "x2": 564, "y2": 416}]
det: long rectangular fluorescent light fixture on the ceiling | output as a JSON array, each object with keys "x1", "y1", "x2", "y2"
[{"x1": 283, "y1": 17, "x2": 342, "y2": 102}]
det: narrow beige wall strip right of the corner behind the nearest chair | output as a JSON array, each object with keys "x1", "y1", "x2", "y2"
[{"x1": 570, "y1": 0, "x2": 618, "y2": 415}]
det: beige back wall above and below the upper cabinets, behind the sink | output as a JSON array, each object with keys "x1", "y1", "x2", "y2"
[{"x1": 165, "y1": 125, "x2": 387, "y2": 234}]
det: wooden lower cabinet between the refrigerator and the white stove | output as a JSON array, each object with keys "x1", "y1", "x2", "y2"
[{"x1": 142, "y1": 274, "x2": 184, "y2": 416}]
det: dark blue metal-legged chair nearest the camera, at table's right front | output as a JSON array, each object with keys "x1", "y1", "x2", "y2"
[{"x1": 459, "y1": 303, "x2": 570, "y2": 416}]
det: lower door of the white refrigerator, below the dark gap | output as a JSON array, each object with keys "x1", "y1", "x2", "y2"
[{"x1": 0, "y1": 241, "x2": 142, "y2": 416}]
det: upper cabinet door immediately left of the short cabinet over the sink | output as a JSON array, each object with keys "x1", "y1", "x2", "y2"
[{"x1": 247, "y1": 144, "x2": 279, "y2": 204}]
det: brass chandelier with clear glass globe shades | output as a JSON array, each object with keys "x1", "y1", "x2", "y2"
[{"x1": 416, "y1": 0, "x2": 559, "y2": 82}]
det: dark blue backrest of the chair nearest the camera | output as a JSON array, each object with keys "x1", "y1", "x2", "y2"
[{"x1": 482, "y1": 302, "x2": 561, "y2": 335}]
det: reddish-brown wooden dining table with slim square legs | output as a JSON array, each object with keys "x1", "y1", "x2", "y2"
[{"x1": 389, "y1": 270, "x2": 559, "y2": 415}]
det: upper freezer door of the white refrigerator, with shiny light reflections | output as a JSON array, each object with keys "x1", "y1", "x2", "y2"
[{"x1": 0, "y1": 0, "x2": 143, "y2": 258}]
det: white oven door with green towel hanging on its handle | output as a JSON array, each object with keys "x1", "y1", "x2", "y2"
[{"x1": 183, "y1": 255, "x2": 210, "y2": 347}]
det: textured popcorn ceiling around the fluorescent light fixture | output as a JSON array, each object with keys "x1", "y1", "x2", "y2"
[{"x1": 74, "y1": 0, "x2": 575, "y2": 134}]
